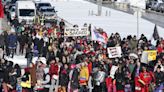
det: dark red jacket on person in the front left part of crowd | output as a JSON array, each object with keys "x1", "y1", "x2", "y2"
[{"x1": 49, "y1": 63, "x2": 59, "y2": 77}]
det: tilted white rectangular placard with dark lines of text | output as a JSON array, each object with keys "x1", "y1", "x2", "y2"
[{"x1": 107, "y1": 46, "x2": 122, "y2": 58}]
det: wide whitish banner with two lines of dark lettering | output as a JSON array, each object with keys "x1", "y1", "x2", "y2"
[{"x1": 64, "y1": 27, "x2": 89, "y2": 37}]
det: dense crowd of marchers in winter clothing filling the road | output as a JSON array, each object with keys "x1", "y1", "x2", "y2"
[{"x1": 0, "y1": 13, "x2": 164, "y2": 92}]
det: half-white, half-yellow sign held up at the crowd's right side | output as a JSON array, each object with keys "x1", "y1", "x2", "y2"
[{"x1": 141, "y1": 50, "x2": 157, "y2": 64}]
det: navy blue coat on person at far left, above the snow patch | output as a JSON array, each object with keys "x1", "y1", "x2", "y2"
[{"x1": 7, "y1": 34, "x2": 17, "y2": 48}]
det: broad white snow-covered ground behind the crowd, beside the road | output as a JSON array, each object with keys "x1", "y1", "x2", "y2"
[{"x1": 46, "y1": 0, "x2": 164, "y2": 39}]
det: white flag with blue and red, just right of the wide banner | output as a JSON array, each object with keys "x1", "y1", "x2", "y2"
[{"x1": 91, "y1": 29, "x2": 108, "y2": 43}]
